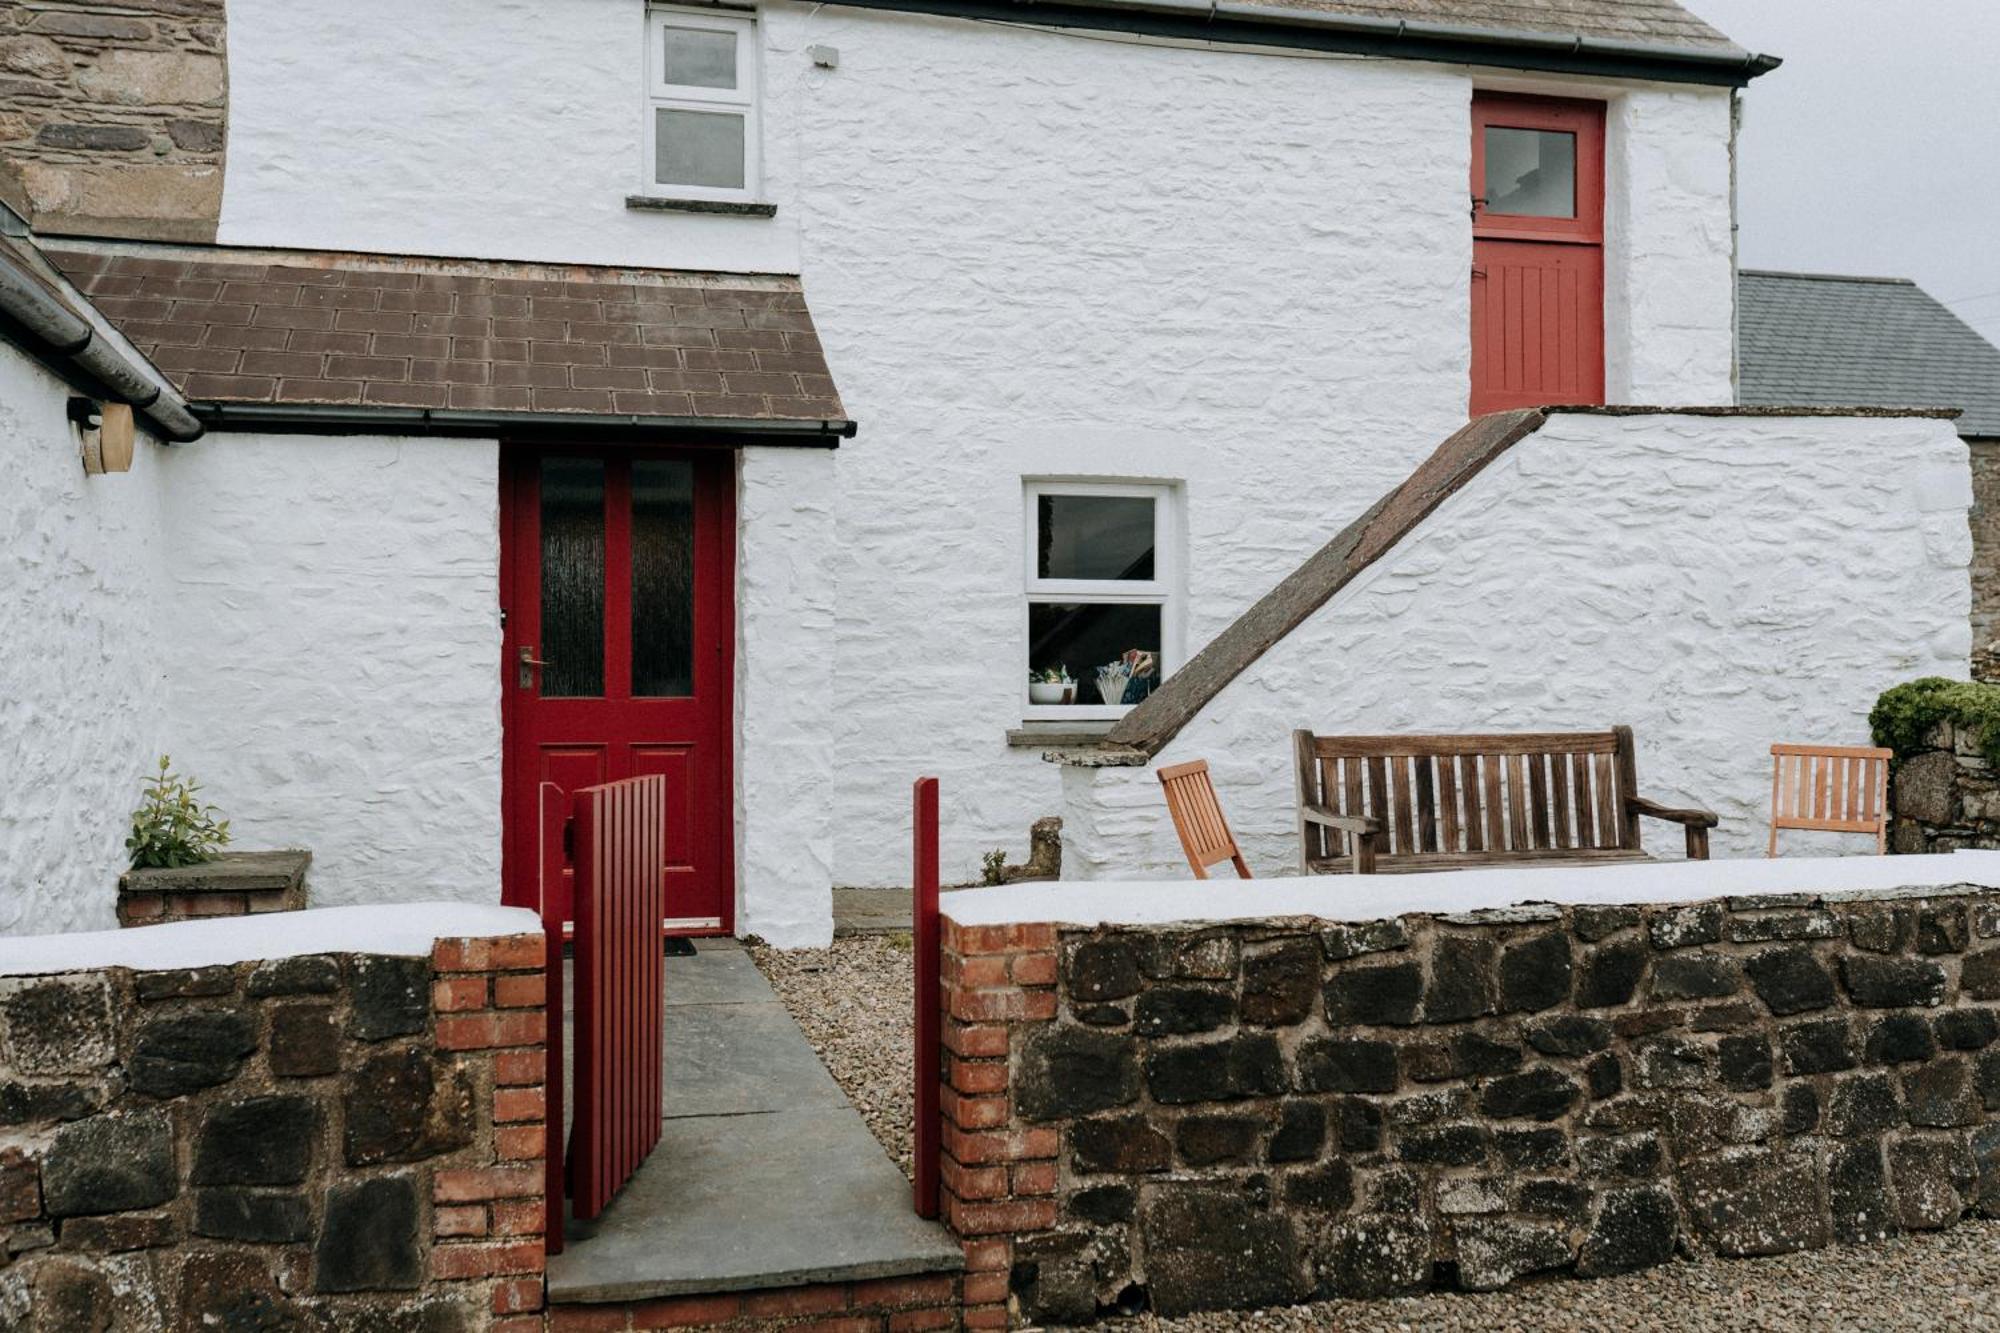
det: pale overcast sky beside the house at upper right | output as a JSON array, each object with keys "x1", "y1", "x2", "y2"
[{"x1": 1682, "y1": 0, "x2": 2000, "y2": 342}]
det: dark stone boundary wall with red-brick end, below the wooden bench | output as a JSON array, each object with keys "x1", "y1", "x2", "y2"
[{"x1": 944, "y1": 887, "x2": 2000, "y2": 1327}]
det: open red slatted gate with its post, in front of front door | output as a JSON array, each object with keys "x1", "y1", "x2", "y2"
[{"x1": 542, "y1": 775, "x2": 666, "y2": 1253}]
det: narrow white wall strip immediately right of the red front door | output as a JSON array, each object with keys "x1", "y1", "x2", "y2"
[{"x1": 736, "y1": 446, "x2": 846, "y2": 947}]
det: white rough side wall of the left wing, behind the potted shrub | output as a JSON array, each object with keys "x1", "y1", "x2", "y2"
[{"x1": 0, "y1": 342, "x2": 166, "y2": 933}]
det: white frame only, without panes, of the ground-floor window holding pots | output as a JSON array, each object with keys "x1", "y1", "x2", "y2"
[{"x1": 1014, "y1": 478, "x2": 1184, "y2": 723}]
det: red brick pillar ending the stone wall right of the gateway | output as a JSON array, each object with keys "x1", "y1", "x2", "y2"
[{"x1": 938, "y1": 917, "x2": 1058, "y2": 1329}]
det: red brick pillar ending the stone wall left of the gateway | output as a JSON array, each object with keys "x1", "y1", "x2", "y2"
[{"x1": 430, "y1": 935, "x2": 548, "y2": 1333}]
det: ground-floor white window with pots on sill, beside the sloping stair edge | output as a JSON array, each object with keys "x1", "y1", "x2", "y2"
[{"x1": 1024, "y1": 480, "x2": 1180, "y2": 719}]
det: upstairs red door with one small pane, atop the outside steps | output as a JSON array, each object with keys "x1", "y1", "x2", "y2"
[{"x1": 1470, "y1": 92, "x2": 1604, "y2": 416}]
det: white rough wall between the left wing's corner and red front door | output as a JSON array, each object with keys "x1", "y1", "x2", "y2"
[{"x1": 150, "y1": 434, "x2": 500, "y2": 907}]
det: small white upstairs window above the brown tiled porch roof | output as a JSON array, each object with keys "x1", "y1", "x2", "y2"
[{"x1": 646, "y1": 10, "x2": 758, "y2": 200}]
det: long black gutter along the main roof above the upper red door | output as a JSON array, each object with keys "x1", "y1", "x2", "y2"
[{"x1": 830, "y1": 0, "x2": 1780, "y2": 88}]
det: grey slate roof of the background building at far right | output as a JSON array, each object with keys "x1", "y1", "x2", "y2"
[{"x1": 1736, "y1": 268, "x2": 2000, "y2": 438}]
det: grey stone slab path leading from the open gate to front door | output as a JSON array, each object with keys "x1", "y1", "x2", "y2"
[{"x1": 548, "y1": 941, "x2": 964, "y2": 1303}]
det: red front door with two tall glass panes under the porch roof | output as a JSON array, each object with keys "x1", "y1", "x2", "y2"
[{"x1": 500, "y1": 444, "x2": 736, "y2": 935}]
